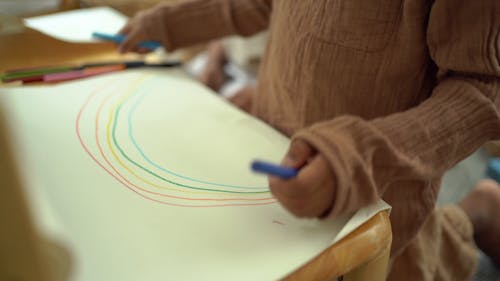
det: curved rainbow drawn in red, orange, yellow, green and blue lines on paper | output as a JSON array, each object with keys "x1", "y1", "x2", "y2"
[{"x1": 75, "y1": 75, "x2": 276, "y2": 208}]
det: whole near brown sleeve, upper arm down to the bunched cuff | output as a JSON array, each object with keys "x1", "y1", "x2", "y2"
[{"x1": 294, "y1": 0, "x2": 500, "y2": 216}]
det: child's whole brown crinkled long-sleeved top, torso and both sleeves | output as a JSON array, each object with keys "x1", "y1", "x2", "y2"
[{"x1": 138, "y1": 0, "x2": 500, "y2": 255}]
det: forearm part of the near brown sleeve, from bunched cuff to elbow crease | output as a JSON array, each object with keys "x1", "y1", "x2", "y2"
[{"x1": 293, "y1": 79, "x2": 500, "y2": 219}]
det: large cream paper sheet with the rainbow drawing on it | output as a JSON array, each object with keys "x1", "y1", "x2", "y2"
[{"x1": 0, "y1": 69, "x2": 389, "y2": 281}]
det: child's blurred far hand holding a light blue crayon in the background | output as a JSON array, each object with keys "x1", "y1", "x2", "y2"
[{"x1": 118, "y1": 10, "x2": 162, "y2": 54}]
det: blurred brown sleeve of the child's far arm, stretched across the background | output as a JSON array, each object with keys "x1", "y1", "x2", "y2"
[{"x1": 143, "y1": 0, "x2": 272, "y2": 51}]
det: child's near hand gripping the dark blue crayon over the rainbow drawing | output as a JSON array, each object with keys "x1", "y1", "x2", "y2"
[{"x1": 269, "y1": 139, "x2": 335, "y2": 217}]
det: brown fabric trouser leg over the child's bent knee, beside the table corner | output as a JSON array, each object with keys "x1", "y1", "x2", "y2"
[{"x1": 388, "y1": 205, "x2": 478, "y2": 281}]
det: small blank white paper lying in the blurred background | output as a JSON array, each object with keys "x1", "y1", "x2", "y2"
[{"x1": 24, "y1": 7, "x2": 128, "y2": 43}]
